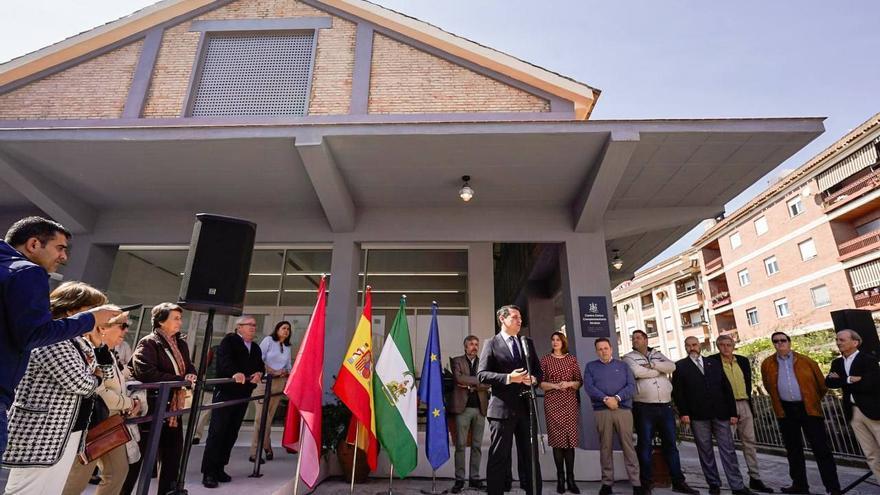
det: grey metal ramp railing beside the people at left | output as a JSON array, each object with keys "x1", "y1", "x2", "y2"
[{"x1": 126, "y1": 375, "x2": 283, "y2": 495}]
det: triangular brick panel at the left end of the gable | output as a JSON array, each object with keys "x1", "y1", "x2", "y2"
[{"x1": 0, "y1": 41, "x2": 143, "y2": 119}]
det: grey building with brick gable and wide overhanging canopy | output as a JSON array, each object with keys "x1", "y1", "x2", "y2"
[{"x1": 0, "y1": 0, "x2": 823, "y2": 478}]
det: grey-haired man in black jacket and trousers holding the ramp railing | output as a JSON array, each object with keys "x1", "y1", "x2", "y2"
[{"x1": 202, "y1": 315, "x2": 265, "y2": 488}]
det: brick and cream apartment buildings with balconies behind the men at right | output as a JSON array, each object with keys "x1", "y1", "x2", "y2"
[{"x1": 612, "y1": 114, "x2": 880, "y2": 350}]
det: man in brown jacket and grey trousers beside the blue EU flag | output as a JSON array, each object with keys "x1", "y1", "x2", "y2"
[{"x1": 449, "y1": 335, "x2": 489, "y2": 493}]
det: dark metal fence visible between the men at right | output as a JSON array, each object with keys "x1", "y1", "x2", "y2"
[{"x1": 678, "y1": 394, "x2": 865, "y2": 460}]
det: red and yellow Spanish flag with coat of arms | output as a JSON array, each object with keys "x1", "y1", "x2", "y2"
[{"x1": 333, "y1": 286, "x2": 379, "y2": 470}]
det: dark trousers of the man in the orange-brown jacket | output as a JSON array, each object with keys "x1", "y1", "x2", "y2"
[{"x1": 779, "y1": 401, "x2": 840, "y2": 490}]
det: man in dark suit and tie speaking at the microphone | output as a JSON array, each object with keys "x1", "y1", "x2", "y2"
[{"x1": 477, "y1": 305, "x2": 541, "y2": 495}]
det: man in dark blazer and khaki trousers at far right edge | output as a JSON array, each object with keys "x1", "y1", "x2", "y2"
[{"x1": 825, "y1": 330, "x2": 880, "y2": 480}]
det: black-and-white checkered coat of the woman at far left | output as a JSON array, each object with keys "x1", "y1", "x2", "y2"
[{"x1": 3, "y1": 339, "x2": 101, "y2": 467}]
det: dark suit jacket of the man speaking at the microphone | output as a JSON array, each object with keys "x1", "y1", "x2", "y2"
[{"x1": 477, "y1": 333, "x2": 543, "y2": 419}]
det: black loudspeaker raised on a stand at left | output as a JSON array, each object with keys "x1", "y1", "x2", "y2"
[{"x1": 178, "y1": 213, "x2": 257, "y2": 316}]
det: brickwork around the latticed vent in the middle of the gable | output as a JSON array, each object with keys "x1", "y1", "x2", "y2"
[{"x1": 144, "y1": 0, "x2": 356, "y2": 117}]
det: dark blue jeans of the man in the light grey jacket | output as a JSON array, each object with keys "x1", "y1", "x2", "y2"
[{"x1": 633, "y1": 402, "x2": 684, "y2": 485}]
